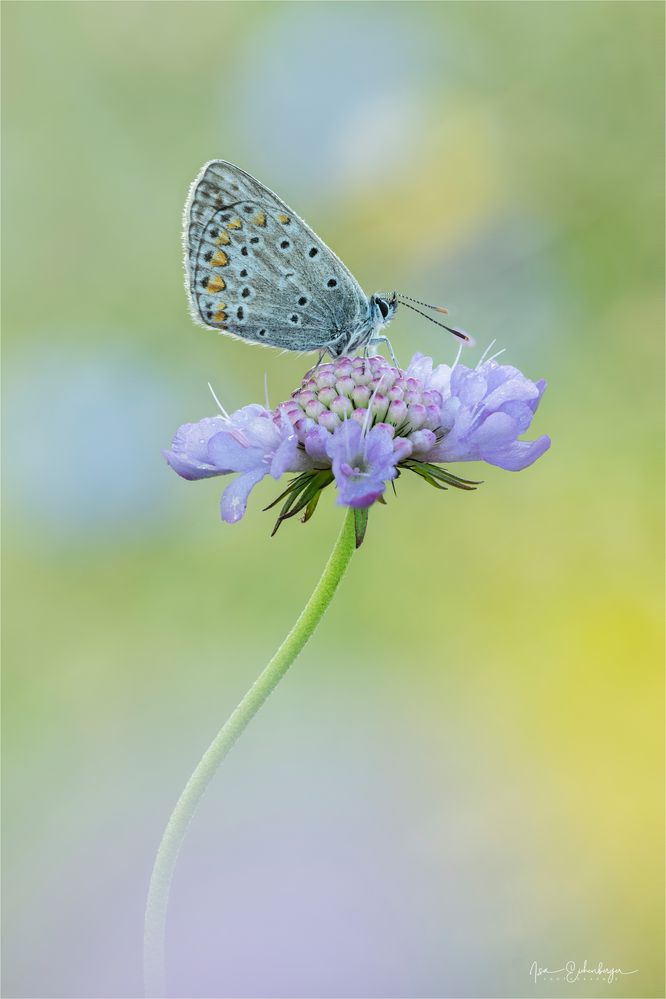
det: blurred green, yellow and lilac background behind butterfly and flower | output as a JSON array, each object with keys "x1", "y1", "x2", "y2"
[{"x1": 2, "y1": 2, "x2": 664, "y2": 997}]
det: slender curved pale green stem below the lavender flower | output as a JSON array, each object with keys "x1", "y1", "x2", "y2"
[{"x1": 144, "y1": 509, "x2": 355, "y2": 997}]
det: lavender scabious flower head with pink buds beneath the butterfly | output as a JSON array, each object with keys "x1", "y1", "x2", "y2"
[{"x1": 164, "y1": 354, "x2": 550, "y2": 539}]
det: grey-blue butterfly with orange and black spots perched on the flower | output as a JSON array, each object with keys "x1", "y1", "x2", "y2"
[{"x1": 183, "y1": 160, "x2": 471, "y2": 360}]
